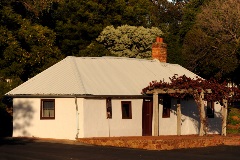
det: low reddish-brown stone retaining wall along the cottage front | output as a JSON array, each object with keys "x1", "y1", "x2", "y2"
[{"x1": 77, "y1": 135, "x2": 240, "y2": 150}]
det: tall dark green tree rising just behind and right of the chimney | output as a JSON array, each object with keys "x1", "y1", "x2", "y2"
[{"x1": 150, "y1": 0, "x2": 188, "y2": 65}]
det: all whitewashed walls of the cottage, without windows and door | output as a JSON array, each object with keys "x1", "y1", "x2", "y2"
[{"x1": 13, "y1": 98, "x2": 221, "y2": 139}]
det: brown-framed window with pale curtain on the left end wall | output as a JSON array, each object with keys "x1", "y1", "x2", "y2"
[{"x1": 40, "y1": 99, "x2": 55, "y2": 119}]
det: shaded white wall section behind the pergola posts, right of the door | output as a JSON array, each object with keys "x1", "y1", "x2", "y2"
[{"x1": 159, "y1": 99, "x2": 222, "y2": 135}]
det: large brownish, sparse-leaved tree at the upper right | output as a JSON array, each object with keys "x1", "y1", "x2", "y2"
[{"x1": 183, "y1": 0, "x2": 240, "y2": 81}]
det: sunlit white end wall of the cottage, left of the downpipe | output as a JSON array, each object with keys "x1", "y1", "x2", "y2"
[{"x1": 13, "y1": 98, "x2": 83, "y2": 139}]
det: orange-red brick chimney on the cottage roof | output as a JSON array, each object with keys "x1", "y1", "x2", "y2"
[{"x1": 152, "y1": 37, "x2": 167, "y2": 63}]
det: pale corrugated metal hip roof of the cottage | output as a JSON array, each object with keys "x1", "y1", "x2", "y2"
[{"x1": 6, "y1": 56, "x2": 197, "y2": 95}]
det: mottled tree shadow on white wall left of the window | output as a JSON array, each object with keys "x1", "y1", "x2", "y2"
[{"x1": 13, "y1": 101, "x2": 34, "y2": 137}]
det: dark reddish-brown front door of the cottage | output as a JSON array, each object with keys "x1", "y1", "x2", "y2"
[{"x1": 142, "y1": 99, "x2": 153, "y2": 136}]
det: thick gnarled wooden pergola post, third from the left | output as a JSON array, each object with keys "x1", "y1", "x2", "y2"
[{"x1": 199, "y1": 91, "x2": 206, "y2": 136}]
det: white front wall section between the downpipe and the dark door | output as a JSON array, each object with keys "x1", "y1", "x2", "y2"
[{"x1": 83, "y1": 99, "x2": 142, "y2": 137}]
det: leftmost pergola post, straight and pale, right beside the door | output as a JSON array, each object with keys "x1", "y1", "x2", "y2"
[{"x1": 153, "y1": 92, "x2": 159, "y2": 136}]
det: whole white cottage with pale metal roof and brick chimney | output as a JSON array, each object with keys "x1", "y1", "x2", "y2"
[{"x1": 6, "y1": 39, "x2": 221, "y2": 139}]
